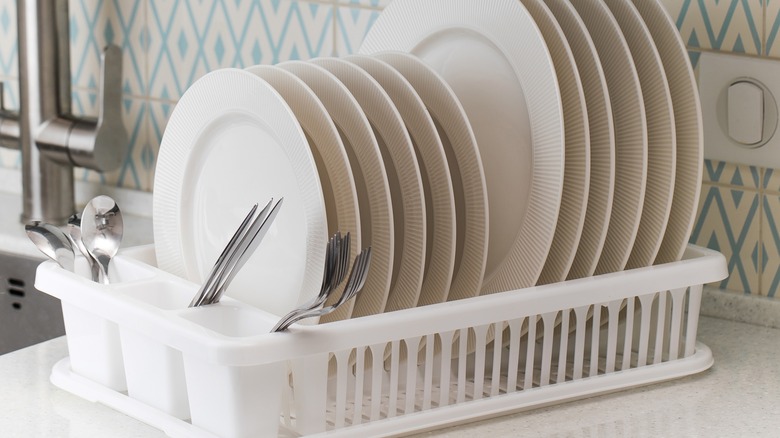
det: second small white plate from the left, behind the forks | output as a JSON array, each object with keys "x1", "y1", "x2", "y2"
[{"x1": 246, "y1": 65, "x2": 361, "y2": 322}]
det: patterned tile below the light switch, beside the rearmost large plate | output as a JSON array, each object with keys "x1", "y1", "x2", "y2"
[{"x1": 691, "y1": 184, "x2": 762, "y2": 293}]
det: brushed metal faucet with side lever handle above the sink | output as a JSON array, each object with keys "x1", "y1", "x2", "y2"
[{"x1": 0, "y1": 0, "x2": 127, "y2": 224}]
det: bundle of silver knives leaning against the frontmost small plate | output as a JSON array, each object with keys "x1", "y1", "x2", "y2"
[{"x1": 190, "y1": 198, "x2": 284, "y2": 307}]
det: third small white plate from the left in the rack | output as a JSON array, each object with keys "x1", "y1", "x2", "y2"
[{"x1": 278, "y1": 61, "x2": 394, "y2": 321}]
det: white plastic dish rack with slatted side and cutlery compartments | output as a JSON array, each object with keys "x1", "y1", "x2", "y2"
[{"x1": 36, "y1": 246, "x2": 727, "y2": 437}]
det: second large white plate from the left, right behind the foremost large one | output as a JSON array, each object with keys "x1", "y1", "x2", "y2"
[{"x1": 522, "y1": 0, "x2": 590, "y2": 284}]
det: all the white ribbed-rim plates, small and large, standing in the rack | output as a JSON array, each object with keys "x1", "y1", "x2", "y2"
[{"x1": 154, "y1": 0, "x2": 702, "y2": 321}]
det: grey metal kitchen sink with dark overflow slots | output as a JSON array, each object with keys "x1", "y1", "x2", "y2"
[{"x1": 0, "y1": 252, "x2": 65, "y2": 354}]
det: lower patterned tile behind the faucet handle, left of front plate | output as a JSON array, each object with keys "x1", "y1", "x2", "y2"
[{"x1": 73, "y1": 90, "x2": 149, "y2": 190}]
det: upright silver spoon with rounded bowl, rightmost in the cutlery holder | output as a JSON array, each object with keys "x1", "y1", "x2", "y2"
[{"x1": 81, "y1": 195, "x2": 124, "y2": 284}]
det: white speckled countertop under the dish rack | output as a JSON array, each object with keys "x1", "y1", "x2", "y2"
[{"x1": 0, "y1": 317, "x2": 780, "y2": 438}]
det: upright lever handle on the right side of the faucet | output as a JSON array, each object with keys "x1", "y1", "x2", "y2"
[{"x1": 68, "y1": 44, "x2": 128, "y2": 172}]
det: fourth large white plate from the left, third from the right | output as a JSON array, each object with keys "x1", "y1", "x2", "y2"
[{"x1": 570, "y1": 0, "x2": 647, "y2": 274}]
